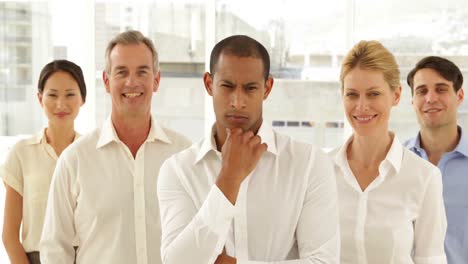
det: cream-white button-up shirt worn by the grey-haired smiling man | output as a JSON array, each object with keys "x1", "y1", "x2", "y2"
[{"x1": 40, "y1": 118, "x2": 190, "y2": 264}]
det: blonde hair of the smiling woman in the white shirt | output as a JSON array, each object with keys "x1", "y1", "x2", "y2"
[{"x1": 340, "y1": 40, "x2": 400, "y2": 91}]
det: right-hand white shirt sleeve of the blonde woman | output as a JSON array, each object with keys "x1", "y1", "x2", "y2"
[{"x1": 414, "y1": 168, "x2": 447, "y2": 264}]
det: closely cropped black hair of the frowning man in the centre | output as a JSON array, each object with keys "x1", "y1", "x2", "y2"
[{"x1": 210, "y1": 35, "x2": 270, "y2": 80}]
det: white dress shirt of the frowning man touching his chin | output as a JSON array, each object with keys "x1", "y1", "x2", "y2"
[{"x1": 158, "y1": 123, "x2": 339, "y2": 264}]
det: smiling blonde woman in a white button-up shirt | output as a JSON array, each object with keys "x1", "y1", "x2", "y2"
[{"x1": 332, "y1": 41, "x2": 447, "y2": 264}]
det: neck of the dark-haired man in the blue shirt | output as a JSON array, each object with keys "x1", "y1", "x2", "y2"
[{"x1": 420, "y1": 125, "x2": 460, "y2": 165}]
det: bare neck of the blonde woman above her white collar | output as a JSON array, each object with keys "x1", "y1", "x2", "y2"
[{"x1": 346, "y1": 131, "x2": 394, "y2": 164}]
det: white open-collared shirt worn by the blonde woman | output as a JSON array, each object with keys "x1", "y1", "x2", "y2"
[{"x1": 332, "y1": 136, "x2": 447, "y2": 264}]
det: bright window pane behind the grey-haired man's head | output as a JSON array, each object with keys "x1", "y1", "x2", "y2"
[{"x1": 95, "y1": 1, "x2": 205, "y2": 140}]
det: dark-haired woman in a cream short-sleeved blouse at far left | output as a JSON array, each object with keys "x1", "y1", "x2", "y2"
[{"x1": 1, "y1": 60, "x2": 86, "y2": 264}]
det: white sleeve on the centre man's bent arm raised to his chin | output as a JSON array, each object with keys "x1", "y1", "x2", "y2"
[{"x1": 158, "y1": 157, "x2": 235, "y2": 264}]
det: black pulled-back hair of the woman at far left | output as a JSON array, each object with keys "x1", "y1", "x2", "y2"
[{"x1": 37, "y1": 60, "x2": 86, "y2": 102}]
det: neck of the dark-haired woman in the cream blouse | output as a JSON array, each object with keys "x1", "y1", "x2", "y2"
[{"x1": 45, "y1": 122, "x2": 76, "y2": 156}]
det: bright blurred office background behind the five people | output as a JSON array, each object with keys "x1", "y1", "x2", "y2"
[{"x1": 0, "y1": 0, "x2": 468, "y2": 263}]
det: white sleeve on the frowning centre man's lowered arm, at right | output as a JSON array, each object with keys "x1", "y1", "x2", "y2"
[{"x1": 241, "y1": 150, "x2": 340, "y2": 264}]
